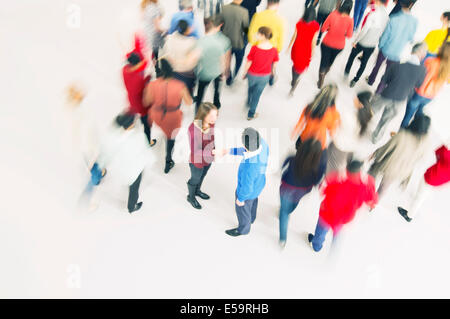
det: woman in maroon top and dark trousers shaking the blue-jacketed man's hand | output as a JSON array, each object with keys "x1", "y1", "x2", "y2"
[{"x1": 187, "y1": 103, "x2": 218, "y2": 209}]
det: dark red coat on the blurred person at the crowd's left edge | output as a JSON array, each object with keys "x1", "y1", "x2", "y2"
[{"x1": 122, "y1": 63, "x2": 150, "y2": 116}]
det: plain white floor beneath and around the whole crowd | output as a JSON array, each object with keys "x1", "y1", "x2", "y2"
[{"x1": 0, "y1": 0, "x2": 450, "y2": 298}]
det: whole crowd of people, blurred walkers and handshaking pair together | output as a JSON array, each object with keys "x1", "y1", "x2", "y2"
[{"x1": 71, "y1": 0, "x2": 450, "y2": 255}]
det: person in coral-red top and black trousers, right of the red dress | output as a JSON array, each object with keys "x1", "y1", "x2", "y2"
[{"x1": 317, "y1": 0, "x2": 353, "y2": 89}]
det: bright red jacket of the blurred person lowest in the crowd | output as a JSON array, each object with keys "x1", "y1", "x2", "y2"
[{"x1": 319, "y1": 172, "x2": 378, "y2": 232}]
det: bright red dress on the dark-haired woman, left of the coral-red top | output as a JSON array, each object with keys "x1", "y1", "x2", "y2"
[{"x1": 291, "y1": 19, "x2": 320, "y2": 73}]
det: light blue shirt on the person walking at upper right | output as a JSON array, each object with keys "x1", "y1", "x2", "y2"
[{"x1": 378, "y1": 11, "x2": 418, "y2": 62}]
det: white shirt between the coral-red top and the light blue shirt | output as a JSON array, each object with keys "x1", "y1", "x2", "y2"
[{"x1": 356, "y1": 6, "x2": 389, "y2": 48}]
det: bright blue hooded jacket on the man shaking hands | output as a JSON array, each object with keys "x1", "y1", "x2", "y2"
[{"x1": 230, "y1": 139, "x2": 269, "y2": 202}]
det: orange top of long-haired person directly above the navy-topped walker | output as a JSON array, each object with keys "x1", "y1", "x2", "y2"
[{"x1": 292, "y1": 105, "x2": 341, "y2": 149}]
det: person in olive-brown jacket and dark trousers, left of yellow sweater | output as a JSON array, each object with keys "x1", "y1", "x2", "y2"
[{"x1": 222, "y1": 0, "x2": 249, "y2": 85}]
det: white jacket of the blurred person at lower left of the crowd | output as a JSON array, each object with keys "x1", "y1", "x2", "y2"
[{"x1": 98, "y1": 126, "x2": 155, "y2": 185}]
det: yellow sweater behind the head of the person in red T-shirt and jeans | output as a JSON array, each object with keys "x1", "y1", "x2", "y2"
[{"x1": 248, "y1": 9, "x2": 285, "y2": 52}]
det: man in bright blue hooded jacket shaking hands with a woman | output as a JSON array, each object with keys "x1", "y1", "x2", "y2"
[{"x1": 216, "y1": 128, "x2": 269, "y2": 237}]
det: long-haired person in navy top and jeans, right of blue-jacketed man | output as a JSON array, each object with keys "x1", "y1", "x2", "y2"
[{"x1": 279, "y1": 139, "x2": 327, "y2": 248}]
